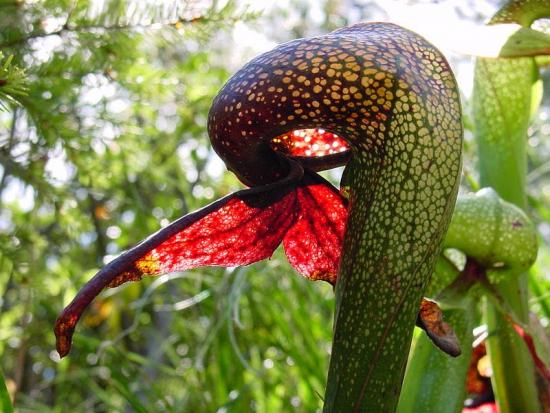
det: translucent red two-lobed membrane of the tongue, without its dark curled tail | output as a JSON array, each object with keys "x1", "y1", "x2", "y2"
[{"x1": 135, "y1": 169, "x2": 347, "y2": 284}]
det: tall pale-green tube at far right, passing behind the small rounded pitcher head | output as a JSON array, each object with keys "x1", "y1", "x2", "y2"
[{"x1": 474, "y1": 55, "x2": 541, "y2": 413}]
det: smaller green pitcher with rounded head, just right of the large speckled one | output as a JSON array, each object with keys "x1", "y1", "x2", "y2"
[{"x1": 398, "y1": 188, "x2": 537, "y2": 413}]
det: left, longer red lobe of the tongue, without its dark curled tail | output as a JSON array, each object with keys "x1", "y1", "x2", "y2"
[{"x1": 136, "y1": 187, "x2": 297, "y2": 275}]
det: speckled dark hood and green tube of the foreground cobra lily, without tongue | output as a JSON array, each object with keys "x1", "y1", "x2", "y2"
[{"x1": 209, "y1": 23, "x2": 462, "y2": 413}]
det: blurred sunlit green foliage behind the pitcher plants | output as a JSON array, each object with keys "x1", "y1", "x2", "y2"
[{"x1": 0, "y1": 0, "x2": 550, "y2": 412}]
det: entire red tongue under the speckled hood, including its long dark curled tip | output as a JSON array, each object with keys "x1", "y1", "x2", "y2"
[{"x1": 55, "y1": 161, "x2": 347, "y2": 357}]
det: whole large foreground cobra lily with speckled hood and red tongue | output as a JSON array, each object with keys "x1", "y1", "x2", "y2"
[{"x1": 55, "y1": 23, "x2": 462, "y2": 411}]
